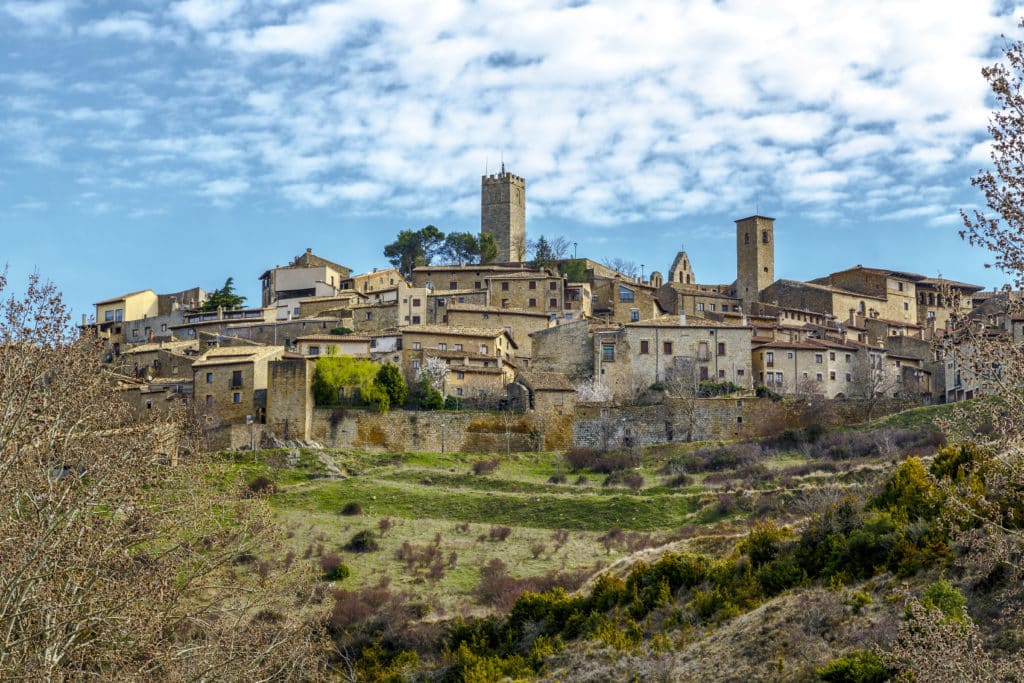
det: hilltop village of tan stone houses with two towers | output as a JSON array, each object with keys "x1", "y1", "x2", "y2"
[{"x1": 82, "y1": 168, "x2": 1024, "y2": 451}]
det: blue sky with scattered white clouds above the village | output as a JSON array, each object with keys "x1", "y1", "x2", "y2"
[{"x1": 0, "y1": 0, "x2": 1020, "y2": 321}]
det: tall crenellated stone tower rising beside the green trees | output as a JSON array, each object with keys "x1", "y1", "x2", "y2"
[{"x1": 480, "y1": 164, "x2": 526, "y2": 263}]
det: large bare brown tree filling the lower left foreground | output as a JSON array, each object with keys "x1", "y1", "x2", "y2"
[{"x1": 0, "y1": 274, "x2": 326, "y2": 680}]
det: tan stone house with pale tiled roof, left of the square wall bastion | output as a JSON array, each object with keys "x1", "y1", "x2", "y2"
[{"x1": 193, "y1": 346, "x2": 285, "y2": 424}]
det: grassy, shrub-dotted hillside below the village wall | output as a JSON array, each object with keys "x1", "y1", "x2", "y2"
[{"x1": 205, "y1": 401, "x2": 1024, "y2": 681}]
